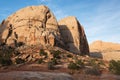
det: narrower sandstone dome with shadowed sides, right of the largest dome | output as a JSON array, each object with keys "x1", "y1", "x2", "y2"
[{"x1": 58, "y1": 16, "x2": 89, "y2": 55}]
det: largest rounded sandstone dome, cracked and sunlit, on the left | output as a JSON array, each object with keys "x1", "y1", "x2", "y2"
[{"x1": 0, "y1": 5, "x2": 60, "y2": 46}]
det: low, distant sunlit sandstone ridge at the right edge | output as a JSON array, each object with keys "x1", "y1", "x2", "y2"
[{"x1": 90, "y1": 40, "x2": 120, "y2": 60}]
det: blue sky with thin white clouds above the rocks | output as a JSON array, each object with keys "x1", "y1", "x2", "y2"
[{"x1": 0, "y1": 0, "x2": 120, "y2": 43}]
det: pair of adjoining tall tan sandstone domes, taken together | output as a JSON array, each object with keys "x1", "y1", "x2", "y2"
[{"x1": 0, "y1": 5, "x2": 89, "y2": 55}]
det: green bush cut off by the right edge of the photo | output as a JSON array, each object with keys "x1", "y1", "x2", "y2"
[{"x1": 109, "y1": 60, "x2": 120, "y2": 75}]
